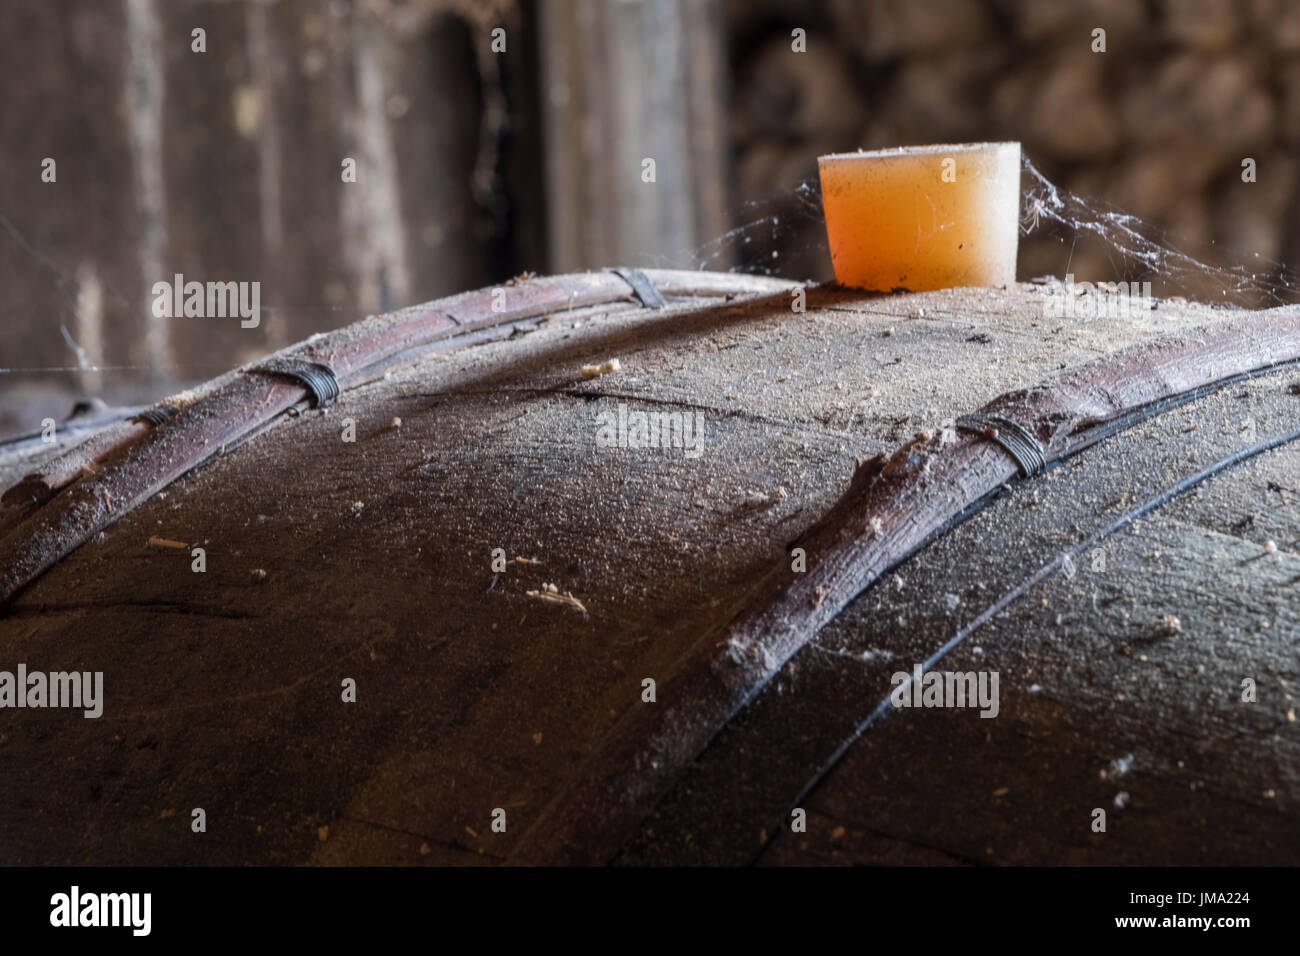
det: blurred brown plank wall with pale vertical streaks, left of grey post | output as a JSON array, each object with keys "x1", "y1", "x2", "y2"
[{"x1": 0, "y1": 0, "x2": 506, "y2": 408}]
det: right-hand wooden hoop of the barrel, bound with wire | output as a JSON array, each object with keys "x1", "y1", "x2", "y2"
[{"x1": 501, "y1": 311, "x2": 1300, "y2": 862}]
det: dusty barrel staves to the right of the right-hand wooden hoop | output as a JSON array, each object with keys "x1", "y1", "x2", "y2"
[{"x1": 620, "y1": 372, "x2": 1300, "y2": 865}]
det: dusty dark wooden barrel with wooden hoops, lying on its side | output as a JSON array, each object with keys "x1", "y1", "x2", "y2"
[{"x1": 0, "y1": 272, "x2": 1300, "y2": 865}]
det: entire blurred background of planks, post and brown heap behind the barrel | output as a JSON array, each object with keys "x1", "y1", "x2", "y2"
[{"x1": 0, "y1": 0, "x2": 1300, "y2": 433}]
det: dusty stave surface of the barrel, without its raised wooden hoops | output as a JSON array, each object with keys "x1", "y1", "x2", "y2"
[{"x1": 0, "y1": 270, "x2": 1300, "y2": 864}]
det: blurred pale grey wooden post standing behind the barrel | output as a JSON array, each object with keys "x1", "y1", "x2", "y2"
[{"x1": 541, "y1": 0, "x2": 731, "y2": 272}]
